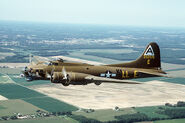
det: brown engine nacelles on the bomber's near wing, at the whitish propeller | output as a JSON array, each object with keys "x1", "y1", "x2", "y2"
[{"x1": 51, "y1": 72, "x2": 87, "y2": 86}]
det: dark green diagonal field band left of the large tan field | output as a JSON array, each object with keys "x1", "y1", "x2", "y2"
[{"x1": 0, "y1": 83, "x2": 77, "y2": 112}]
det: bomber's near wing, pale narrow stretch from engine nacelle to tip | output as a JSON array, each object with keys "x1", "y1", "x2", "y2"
[{"x1": 85, "y1": 75, "x2": 142, "y2": 84}]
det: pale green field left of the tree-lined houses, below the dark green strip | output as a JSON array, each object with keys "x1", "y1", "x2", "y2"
[{"x1": 0, "y1": 99, "x2": 45, "y2": 117}]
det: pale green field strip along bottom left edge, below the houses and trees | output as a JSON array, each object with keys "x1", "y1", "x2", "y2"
[{"x1": 0, "y1": 117, "x2": 78, "y2": 123}]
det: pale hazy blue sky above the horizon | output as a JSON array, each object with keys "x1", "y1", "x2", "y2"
[{"x1": 0, "y1": 0, "x2": 185, "y2": 27}]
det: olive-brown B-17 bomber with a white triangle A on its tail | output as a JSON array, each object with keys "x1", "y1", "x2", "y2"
[{"x1": 23, "y1": 42, "x2": 166, "y2": 86}]
